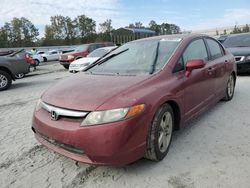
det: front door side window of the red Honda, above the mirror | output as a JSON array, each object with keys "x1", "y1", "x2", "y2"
[{"x1": 183, "y1": 39, "x2": 208, "y2": 64}]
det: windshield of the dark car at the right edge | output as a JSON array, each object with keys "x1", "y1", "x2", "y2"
[{"x1": 223, "y1": 35, "x2": 250, "y2": 48}]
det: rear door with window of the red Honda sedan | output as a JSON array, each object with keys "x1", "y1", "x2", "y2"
[{"x1": 206, "y1": 38, "x2": 228, "y2": 96}]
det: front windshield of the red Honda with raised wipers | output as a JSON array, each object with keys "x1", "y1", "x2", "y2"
[{"x1": 89, "y1": 39, "x2": 180, "y2": 74}]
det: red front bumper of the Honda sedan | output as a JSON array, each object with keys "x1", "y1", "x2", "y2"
[{"x1": 32, "y1": 110, "x2": 150, "y2": 166}]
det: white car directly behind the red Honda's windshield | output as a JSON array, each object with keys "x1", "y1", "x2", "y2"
[{"x1": 69, "y1": 46, "x2": 117, "y2": 73}]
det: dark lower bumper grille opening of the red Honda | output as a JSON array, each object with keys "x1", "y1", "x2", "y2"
[{"x1": 36, "y1": 131, "x2": 85, "y2": 155}]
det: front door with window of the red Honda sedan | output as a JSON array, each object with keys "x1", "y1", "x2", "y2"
[{"x1": 182, "y1": 38, "x2": 215, "y2": 120}]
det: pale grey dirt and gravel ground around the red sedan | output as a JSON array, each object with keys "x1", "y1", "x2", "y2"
[{"x1": 0, "y1": 63, "x2": 250, "y2": 188}]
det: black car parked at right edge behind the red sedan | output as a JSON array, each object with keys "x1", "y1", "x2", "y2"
[{"x1": 222, "y1": 33, "x2": 250, "y2": 73}]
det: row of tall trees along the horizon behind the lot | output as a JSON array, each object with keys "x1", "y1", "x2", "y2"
[{"x1": 0, "y1": 15, "x2": 184, "y2": 48}]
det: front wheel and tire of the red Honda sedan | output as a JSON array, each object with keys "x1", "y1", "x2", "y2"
[{"x1": 144, "y1": 104, "x2": 175, "y2": 161}]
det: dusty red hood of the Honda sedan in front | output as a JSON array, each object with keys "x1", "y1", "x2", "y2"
[{"x1": 42, "y1": 73, "x2": 150, "y2": 111}]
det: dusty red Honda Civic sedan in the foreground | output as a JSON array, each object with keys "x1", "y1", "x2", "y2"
[{"x1": 32, "y1": 34, "x2": 236, "y2": 165}]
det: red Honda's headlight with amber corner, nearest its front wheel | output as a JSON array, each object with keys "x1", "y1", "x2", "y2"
[{"x1": 81, "y1": 104, "x2": 145, "y2": 126}]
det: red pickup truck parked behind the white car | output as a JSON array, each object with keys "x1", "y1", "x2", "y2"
[{"x1": 59, "y1": 42, "x2": 114, "y2": 69}]
